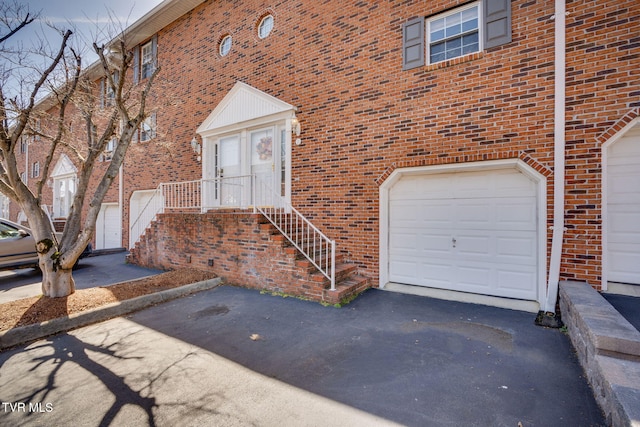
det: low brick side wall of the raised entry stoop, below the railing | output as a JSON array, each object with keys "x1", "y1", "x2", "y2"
[{"x1": 130, "y1": 212, "x2": 325, "y2": 300}]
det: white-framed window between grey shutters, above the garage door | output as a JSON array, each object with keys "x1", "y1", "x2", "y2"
[{"x1": 427, "y1": 3, "x2": 481, "y2": 64}]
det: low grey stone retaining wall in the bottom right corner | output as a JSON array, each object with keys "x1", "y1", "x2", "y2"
[{"x1": 560, "y1": 281, "x2": 640, "y2": 427}]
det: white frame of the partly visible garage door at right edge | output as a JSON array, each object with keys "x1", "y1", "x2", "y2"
[{"x1": 600, "y1": 117, "x2": 640, "y2": 296}]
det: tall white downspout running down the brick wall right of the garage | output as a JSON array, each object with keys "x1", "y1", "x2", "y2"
[{"x1": 542, "y1": 0, "x2": 566, "y2": 313}]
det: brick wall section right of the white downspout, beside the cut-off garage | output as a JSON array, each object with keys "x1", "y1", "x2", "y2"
[{"x1": 561, "y1": 0, "x2": 640, "y2": 289}]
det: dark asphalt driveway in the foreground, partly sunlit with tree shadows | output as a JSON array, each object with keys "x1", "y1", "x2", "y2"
[{"x1": 0, "y1": 286, "x2": 605, "y2": 426}]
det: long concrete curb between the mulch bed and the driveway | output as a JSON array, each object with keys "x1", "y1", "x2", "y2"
[{"x1": 0, "y1": 277, "x2": 222, "y2": 350}]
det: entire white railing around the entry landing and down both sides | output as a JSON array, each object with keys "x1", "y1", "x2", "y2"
[{"x1": 129, "y1": 175, "x2": 336, "y2": 290}]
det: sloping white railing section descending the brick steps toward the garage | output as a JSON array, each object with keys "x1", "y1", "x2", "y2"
[{"x1": 254, "y1": 177, "x2": 336, "y2": 291}]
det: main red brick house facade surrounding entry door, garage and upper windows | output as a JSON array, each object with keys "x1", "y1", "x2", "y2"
[{"x1": 12, "y1": 0, "x2": 640, "y2": 286}]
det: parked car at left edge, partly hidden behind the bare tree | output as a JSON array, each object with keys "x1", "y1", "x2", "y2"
[{"x1": 0, "y1": 219, "x2": 92, "y2": 270}]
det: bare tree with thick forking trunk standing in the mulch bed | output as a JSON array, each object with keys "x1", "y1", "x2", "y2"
[{"x1": 0, "y1": 6, "x2": 160, "y2": 297}]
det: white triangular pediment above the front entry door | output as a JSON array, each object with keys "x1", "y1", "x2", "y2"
[{"x1": 197, "y1": 82, "x2": 296, "y2": 136}]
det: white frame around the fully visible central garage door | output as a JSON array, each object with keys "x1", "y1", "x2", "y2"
[{"x1": 379, "y1": 159, "x2": 547, "y2": 312}]
